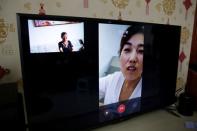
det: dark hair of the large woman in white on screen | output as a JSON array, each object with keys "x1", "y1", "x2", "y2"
[{"x1": 118, "y1": 25, "x2": 144, "y2": 56}]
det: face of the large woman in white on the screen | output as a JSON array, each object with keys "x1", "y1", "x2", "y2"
[{"x1": 120, "y1": 33, "x2": 144, "y2": 80}]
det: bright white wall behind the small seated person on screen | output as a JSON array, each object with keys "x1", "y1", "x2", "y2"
[{"x1": 28, "y1": 20, "x2": 84, "y2": 53}]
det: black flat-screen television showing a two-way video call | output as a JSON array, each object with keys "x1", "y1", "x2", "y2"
[{"x1": 17, "y1": 14, "x2": 181, "y2": 130}]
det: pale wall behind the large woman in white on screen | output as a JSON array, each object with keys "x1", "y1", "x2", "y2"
[{"x1": 99, "y1": 24, "x2": 129, "y2": 77}]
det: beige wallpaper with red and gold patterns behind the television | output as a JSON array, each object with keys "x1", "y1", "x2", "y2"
[{"x1": 0, "y1": 0, "x2": 196, "y2": 89}]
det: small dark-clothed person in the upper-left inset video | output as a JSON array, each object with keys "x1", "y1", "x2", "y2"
[{"x1": 58, "y1": 32, "x2": 73, "y2": 52}]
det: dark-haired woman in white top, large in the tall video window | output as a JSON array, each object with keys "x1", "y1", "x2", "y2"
[{"x1": 99, "y1": 25, "x2": 144, "y2": 105}]
